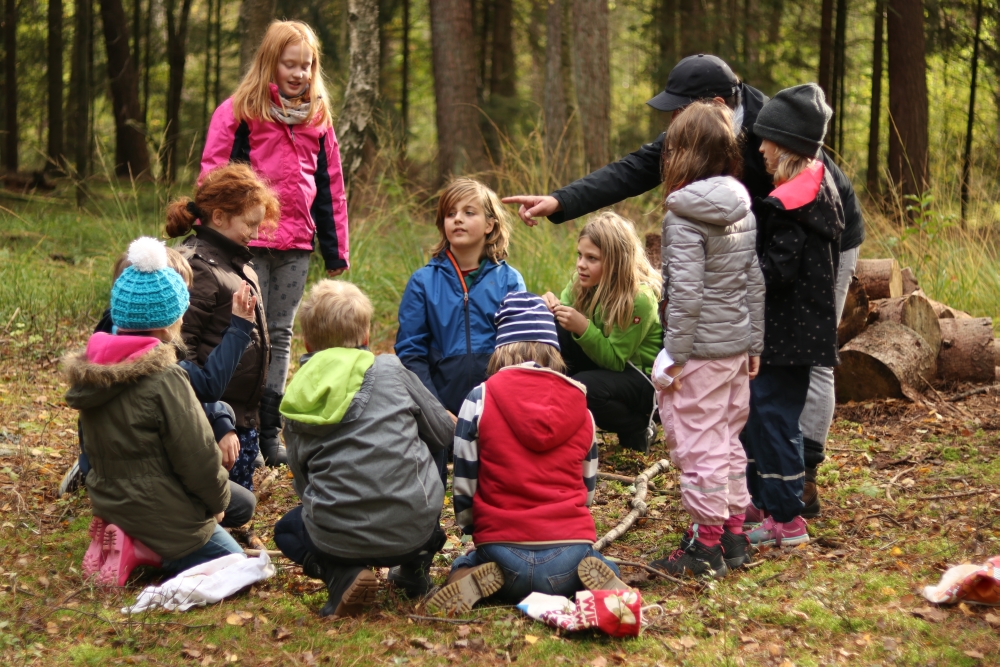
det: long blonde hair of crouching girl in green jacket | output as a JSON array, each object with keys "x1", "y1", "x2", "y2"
[{"x1": 572, "y1": 211, "x2": 663, "y2": 336}]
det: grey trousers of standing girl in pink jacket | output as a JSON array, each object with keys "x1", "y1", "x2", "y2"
[{"x1": 250, "y1": 248, "x2": 312, "y2": 394}]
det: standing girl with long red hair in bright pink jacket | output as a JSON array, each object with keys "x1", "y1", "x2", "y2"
[{"x1": 199, "y1": 21, "x2": 348, "y2": 466}]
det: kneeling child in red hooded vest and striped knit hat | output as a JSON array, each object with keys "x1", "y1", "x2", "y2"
[{"x1": 427, "y1": 292, "x2": 627, "y2": 614}]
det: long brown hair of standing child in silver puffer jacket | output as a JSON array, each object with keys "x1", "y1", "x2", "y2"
[{"x1": 663, "y1": 101, "x2": 743, "y2": 195}]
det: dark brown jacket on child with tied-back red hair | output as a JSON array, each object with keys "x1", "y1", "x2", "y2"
[{"x1": 179, "y1": 225, "x2": 271, "y2": 428}]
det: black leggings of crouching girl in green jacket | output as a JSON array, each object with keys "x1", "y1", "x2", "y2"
[{"x1": 556, "y1": 323, "x2": 653, "y2": 450}]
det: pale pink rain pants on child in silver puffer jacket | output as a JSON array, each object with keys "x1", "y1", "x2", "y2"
[{"x1": 656, "y1": 354, "x2": 750, "y2": 526}]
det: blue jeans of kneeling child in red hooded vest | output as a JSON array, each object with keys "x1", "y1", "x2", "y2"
[{"x1": 451, "y1": 544, "x2": 619, "y2": 603}]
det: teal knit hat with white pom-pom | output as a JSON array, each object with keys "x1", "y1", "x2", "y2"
[{"x1": 111, "y1": 236, "x2": 190, "y2": 331}]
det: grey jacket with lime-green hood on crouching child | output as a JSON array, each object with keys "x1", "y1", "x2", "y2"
[{"x1": 281, "y1": 354, "x2": 455, "y2": 558}]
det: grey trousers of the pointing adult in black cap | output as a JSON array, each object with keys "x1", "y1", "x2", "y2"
[{"x1": 799, "y1": 248, "x2": 861, "y2": 468}]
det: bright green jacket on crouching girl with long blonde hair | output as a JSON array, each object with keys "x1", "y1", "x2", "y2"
[{"x1": 559, "y1": 280, "x2": 663, "y2": 375}]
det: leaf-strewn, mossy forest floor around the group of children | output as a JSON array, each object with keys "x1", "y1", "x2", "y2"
[{"x1": 0, "y1": 330, "x2": 1000, "y2": 667}]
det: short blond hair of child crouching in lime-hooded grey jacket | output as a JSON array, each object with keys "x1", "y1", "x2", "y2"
[{"x1": 299, "y1": 280, "x2": 375, "y2": 352}]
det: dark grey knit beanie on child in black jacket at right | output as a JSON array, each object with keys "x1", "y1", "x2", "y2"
[{"x1": 753, "y1": 83, "x2": 833, "y2": 157}]
